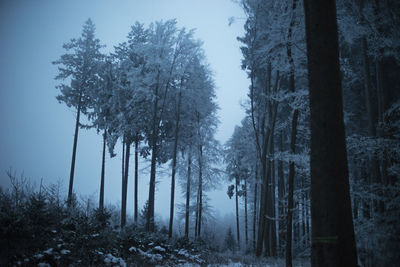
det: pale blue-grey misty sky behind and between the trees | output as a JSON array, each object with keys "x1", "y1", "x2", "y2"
[{"x1": 0, "y1": 0, "x2": 248, "y2": 221}]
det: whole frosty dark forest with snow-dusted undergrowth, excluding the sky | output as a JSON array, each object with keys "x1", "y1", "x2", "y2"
[{"x1": 0, "y1": 0, "x2": 400, "y2": 267}]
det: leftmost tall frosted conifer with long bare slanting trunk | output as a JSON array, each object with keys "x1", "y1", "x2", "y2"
[{"x1": 53, "y1": 19, "x2": 103, "y2": 206}]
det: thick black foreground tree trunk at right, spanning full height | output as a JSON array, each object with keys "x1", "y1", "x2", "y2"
[{"x1": 304, "y1": 0, "x2": 357, "y2": 267}]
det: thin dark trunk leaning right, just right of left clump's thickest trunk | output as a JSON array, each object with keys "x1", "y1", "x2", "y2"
[{"x1": 168, "y1": 91, "x2": 182, "y2": 238}]
